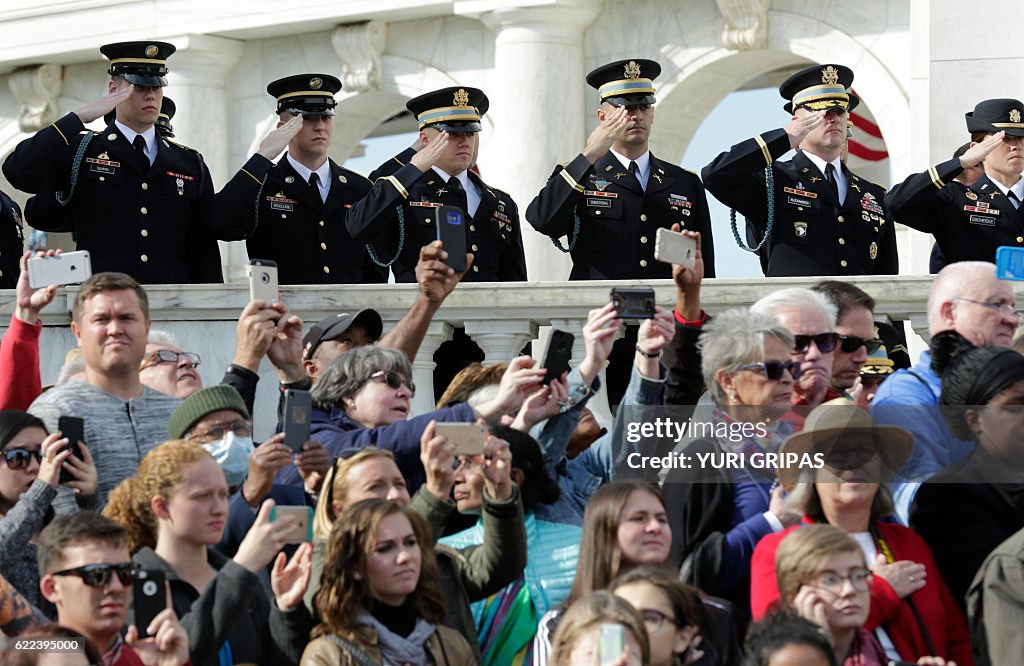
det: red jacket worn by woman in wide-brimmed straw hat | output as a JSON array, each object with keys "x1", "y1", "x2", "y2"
[{"x1": 751, "y1": 518, "x2": 974, "y2": 666}]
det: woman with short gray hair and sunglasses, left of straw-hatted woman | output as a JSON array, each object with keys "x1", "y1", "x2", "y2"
[{"x1": 663, "y1": 309, "x2": 800, "y2": 620}]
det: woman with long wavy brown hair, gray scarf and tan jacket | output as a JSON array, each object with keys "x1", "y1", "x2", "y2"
[{"x1": 301, "y1": 499, "x2": 476, "y2": 666}]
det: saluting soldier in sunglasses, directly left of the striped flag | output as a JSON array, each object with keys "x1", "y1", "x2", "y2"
[{"x1": 701, "y1": 65, "x2": 899, "y2": 277}]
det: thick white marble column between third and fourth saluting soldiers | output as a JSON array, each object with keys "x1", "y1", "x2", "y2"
[{"x1": 454, "y1": 0, "x2": 601, "y2": 280}]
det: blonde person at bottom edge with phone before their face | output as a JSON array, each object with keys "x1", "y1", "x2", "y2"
[{"x1": 551, "y1": 590, "x2": 650, "y2": 666}]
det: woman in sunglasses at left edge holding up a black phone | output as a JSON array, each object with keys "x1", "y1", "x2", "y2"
[{"x1": 0, "y1": 410, "x2": 96, "y2": 608}]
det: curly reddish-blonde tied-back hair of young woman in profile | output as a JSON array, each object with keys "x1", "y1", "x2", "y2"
[{"x1": 103, "y1": 440, "x2": 214, "y2": 554}]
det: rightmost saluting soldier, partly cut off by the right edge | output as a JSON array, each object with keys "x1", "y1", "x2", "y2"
[{"x1": 886, "y1": 99, "x2": 1024, "y2": 264}]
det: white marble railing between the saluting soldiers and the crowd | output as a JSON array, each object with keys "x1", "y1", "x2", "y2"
[{"x1": 0, "y1": 276, "x2": 966, "y2": 436}]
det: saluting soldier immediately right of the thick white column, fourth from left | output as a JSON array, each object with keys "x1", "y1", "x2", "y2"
[{"x1": 526, "y1": 58, "x2": 715, "y2": 278}]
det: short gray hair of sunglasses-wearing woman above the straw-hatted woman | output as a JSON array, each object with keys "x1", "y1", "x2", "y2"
[{"x1": 697, "y1": 307, "x2": 794, "y2": 405}]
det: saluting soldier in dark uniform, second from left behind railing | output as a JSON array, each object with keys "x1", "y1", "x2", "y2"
[{"x1": 217, "y1": 74, "x2": 387, "y2": 285}]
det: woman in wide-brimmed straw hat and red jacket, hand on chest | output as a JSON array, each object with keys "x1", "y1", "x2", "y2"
[{"x1": 751, "y1": 399, "x2": 973, "y2": 666}]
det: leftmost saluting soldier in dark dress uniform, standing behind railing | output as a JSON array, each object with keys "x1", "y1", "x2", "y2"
[{"x1": 3, "y1": 41, "x2": 223, "y2": 284}]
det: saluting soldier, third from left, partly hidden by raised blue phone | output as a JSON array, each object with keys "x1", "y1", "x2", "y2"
[{"x1": 347, "y1": 87, "x2": 526, "y2": 282}]
